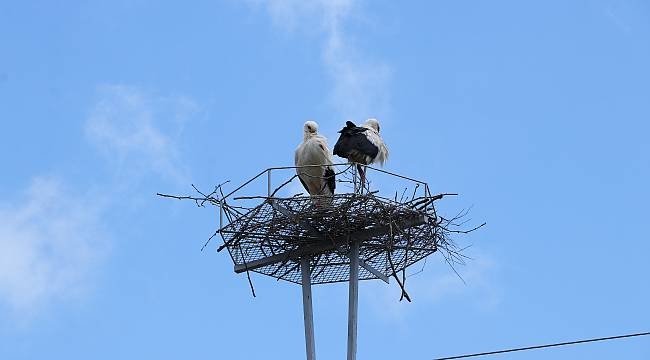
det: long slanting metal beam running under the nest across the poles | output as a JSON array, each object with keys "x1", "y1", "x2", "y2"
[{"x1": 235, "y1": 216, "x2": 425, "y2": 273}]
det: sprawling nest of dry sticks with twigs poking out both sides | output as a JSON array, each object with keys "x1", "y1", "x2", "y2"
[{"x1": 158, "y1": 166, "x2": 485, "y2": 301}]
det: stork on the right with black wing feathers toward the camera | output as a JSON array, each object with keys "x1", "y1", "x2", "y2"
[{"x1": 334, "y1": 118, "x2": 388, "y2": 184}]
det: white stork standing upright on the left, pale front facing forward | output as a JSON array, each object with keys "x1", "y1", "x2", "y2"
[{"x1": 295, "y1": 121, "x2": 336, "y2": 204}]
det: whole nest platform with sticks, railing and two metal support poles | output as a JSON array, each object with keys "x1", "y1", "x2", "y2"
[{"x1": 158, "y1": 164, "x2": 484, "y2": 360}]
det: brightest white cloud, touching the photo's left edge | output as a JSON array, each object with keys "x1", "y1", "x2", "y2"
[{"x1": 0, "y1": 178, "x2": 108, "y2": 316}]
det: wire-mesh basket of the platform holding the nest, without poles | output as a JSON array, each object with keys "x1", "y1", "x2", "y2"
[{"x1": 220, "y1": 193, "x2": 446, "y2": 284}]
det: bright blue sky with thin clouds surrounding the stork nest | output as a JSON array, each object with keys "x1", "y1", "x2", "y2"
[{"x1": 0, "y1": 0, "x2": 650, "y2": 359}]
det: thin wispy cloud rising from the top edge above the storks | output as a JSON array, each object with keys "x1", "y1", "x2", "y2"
[{"x1": 249, "y1": 0, "x2": 391, "y2": 120}]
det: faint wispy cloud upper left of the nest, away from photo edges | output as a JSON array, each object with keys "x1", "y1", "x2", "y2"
[{"x1": 85, "y1": 85, "x2": 198, "y2": 182}]
